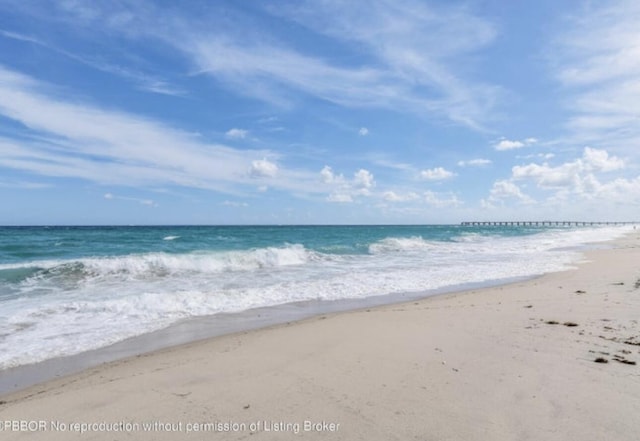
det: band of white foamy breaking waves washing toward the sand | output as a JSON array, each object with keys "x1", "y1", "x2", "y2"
[{"x1": 0, "y1": 227, "x2": 626, "y2": 368}]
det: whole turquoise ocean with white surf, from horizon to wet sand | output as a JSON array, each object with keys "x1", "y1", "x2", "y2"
[{"x1": 0, "y1": 225, "x2": 630, "y2": 370}]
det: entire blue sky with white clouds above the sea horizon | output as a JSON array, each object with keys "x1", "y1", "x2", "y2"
[{"x1": 0, "y1": 0, "x2": 640, "y2": 225}]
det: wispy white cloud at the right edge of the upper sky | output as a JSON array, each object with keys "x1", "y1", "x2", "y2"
[{"x1": 550, "y1": 0, "x2": 640, "y2": 154}]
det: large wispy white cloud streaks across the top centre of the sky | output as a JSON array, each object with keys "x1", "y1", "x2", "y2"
[{"x1": 178, "y1": 0, "x2": 501, "y2": 128}]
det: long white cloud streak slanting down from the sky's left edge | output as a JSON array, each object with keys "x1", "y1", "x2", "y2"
[{"x1": 0, "y1": 67, "x2": 317, "y2": 193}]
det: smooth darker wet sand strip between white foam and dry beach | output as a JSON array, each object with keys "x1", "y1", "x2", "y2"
[{"x1": 0, "y1": 272, "x2": 536, "y2": 399}]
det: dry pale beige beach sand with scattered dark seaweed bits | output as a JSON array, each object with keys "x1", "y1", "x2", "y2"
[{"x1": 0, "y1": 232, "x2": 640, "y2": 441}]
